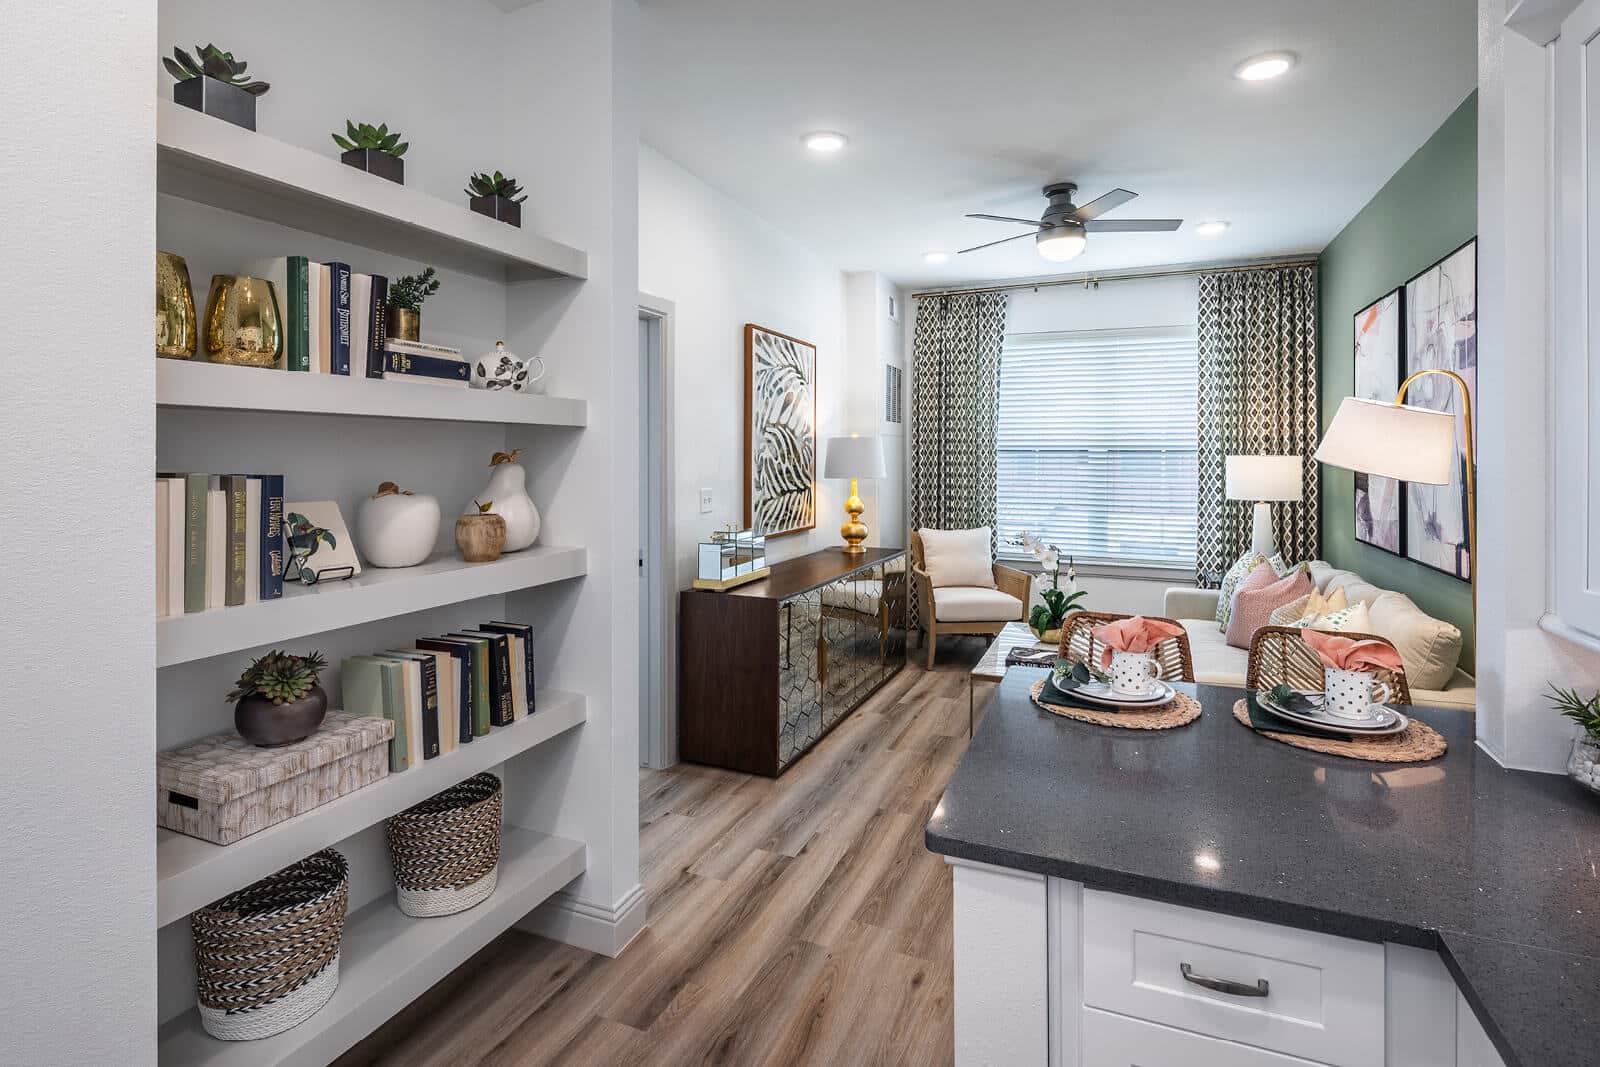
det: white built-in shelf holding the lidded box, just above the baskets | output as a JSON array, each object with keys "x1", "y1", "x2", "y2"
[{"x1": 155, "y1": 689, "x2": 587, "y2": 926}]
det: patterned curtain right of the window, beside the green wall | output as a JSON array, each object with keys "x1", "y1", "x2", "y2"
[{"x1": 1195, "y1": 266, "x2": 1322, "y2": 589}]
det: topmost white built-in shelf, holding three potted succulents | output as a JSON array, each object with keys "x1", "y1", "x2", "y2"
[{"x1": 155, "y1": 99, "x2": 589, "y2": 282}]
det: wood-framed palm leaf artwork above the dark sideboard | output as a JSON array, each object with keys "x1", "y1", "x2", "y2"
[{"x1": 744, "y1": 323, "x2": 816, "y2": 537}]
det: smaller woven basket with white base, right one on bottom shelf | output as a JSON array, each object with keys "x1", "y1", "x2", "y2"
[{"x1": 384, "y1": 773, "x2": 502, "y2": 918}]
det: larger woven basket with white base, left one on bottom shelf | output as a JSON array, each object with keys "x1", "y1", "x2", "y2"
[{"x1": 189, "y1": 848, "x2": 350, "y2": 1041}]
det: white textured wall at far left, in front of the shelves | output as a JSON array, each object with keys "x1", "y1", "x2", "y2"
[{"x1": 0, "y1": 0, "x2": 157, "y2": 1064}]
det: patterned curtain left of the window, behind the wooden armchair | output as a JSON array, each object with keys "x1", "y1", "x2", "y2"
[{"x1": 910, "y1": 293, "x2": 1008, "y2": 619}]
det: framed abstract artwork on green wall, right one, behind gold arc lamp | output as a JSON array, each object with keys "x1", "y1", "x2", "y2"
[{"x1": 1405, "y1": 238, "x2": 1478, "y2": 581}]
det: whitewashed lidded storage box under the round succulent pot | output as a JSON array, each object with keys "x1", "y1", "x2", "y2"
[{"x1": 155, "y1": 712, "x2": 395, "y2": 845}]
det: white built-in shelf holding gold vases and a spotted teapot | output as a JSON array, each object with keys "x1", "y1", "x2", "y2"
[{"x1": 155, "y1": 360, "x2": 589, "y2": 426}]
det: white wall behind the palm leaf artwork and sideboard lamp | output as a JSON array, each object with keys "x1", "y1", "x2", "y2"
[{"x1": 638, "y1": 146, "x2": 877, "y2": 589}]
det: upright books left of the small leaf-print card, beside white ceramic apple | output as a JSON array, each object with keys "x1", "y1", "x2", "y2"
[{"x1": 155, "y1": 474, "x2": 283, "y2": 619}]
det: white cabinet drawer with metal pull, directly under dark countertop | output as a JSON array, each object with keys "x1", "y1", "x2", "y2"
[{"x1": 1070, "y1": 889, "x2": 1384, "y2": 1067}]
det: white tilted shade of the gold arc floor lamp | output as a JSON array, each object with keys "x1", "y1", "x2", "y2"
[{"x1": 1317, "y1": 397, "x2": 1456, "y2": 485}]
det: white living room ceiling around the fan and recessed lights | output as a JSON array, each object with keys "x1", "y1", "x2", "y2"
[{"x1": 642, "y1": 0, "x2": 1477, "y2": 285}]
